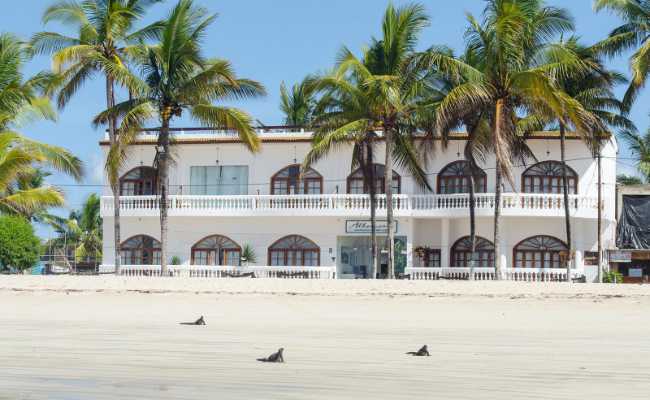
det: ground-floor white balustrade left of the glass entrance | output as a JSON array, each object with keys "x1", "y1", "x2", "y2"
[{"x1": 99, "y1": 265, "x2": 336, "y2": 279}]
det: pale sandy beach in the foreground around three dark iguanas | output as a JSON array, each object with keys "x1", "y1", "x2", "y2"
[{"x1": 0, "y1": 276, "x2": 650, "y2": 400}]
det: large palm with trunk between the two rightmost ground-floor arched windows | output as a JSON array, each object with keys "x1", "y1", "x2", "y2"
[{"x1": 426, "y1": 0, "x2": 593, "y2": 278}]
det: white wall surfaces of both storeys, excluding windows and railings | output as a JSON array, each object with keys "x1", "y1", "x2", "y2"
[{"x1": 103, "y1": 132, "x2": 617, "y2": 265}]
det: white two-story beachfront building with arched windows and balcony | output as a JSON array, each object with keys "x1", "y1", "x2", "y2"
[{"x1": 101, "y1": 128, "x2": 617, "y2": 278}]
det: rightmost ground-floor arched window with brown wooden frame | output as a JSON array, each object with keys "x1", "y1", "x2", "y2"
[{"x1": 514, "y1": 235, "x2": 569, "y2": 268}]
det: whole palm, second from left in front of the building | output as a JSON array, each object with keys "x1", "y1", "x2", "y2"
[{"x1": 95, "y1": 0, "x2": 265, "y2": 274}]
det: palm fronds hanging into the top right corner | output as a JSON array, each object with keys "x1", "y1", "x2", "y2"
[{"x1": 594, "y1": 0, "x2": 650, "y2": 109}]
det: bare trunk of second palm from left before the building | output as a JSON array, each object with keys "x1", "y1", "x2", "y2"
[{"x1": 157, "y1": 110, "x2": 171, "y2": 276}]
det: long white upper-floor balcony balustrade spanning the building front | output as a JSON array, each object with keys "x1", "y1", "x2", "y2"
[{"x1": 101, "y1": 193, "x2": 598, "y2": 218}]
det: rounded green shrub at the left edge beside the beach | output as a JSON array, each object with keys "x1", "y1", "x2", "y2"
[{"x1": 0, "y1": 216, "x2": 41, "y2": 271}]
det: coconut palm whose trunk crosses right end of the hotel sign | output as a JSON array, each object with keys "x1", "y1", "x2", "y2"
[{"x1": 306, "y1": 4, "x2": 433, "y2": 278}]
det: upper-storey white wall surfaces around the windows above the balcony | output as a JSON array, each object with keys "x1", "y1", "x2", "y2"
[{"x1": 104, "y1": 139, "x2": 617, "y2": 205}]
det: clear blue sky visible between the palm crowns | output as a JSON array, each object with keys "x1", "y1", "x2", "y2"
[{"x1": 0, "y1": 0, "x2": 650, "y2": 236}]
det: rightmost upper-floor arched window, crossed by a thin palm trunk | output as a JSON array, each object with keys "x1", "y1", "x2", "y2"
[{"x1": 521, "y1": 161, "x2": 578, "y2": 194}]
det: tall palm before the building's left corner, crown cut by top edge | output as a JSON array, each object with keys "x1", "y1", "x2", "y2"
[{"x1": 31, "y1": 0, "x2": 162, "y2": 273}]
